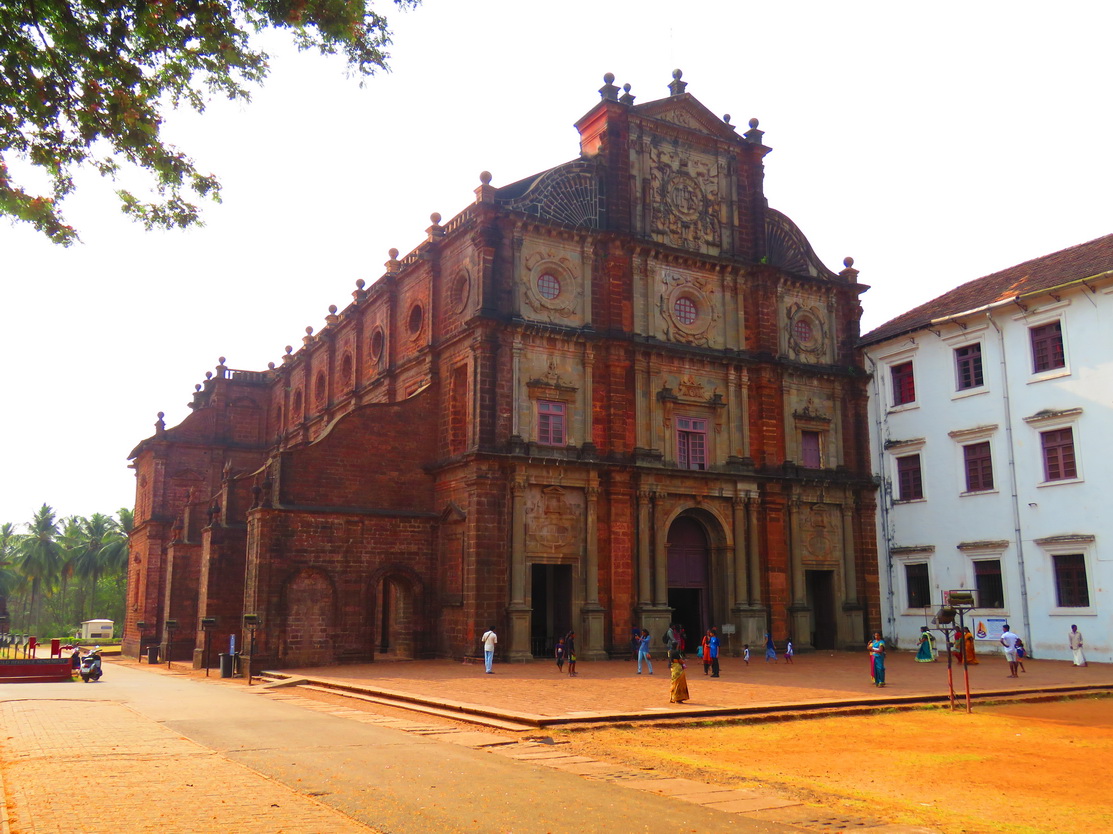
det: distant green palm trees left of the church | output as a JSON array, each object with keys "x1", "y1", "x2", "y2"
[{"x1": 0, "y1": 504, "x2": 132, "y2": 637}]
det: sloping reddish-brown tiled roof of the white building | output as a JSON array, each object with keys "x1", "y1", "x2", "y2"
[{"x1": 859, "y1": 235, "x2": 1113, "y2": 345}]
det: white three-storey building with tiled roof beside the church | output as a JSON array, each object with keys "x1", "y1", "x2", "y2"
[{"x1": 861, "y1": 235, "x2": 1113, "y2": 663}]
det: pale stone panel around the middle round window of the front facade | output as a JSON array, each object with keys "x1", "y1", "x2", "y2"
[{"x1": 650, "y1": 264, "x2": 723, "y2": 347}]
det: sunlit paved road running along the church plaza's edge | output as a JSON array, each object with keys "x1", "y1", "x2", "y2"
[{"x1": 0, "y1": 664, "x2": 800, "y2": 834}]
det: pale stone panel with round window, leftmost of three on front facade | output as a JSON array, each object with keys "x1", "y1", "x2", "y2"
[{"x1": 520, "y1": 241, "x2": 584, "y2": 325}]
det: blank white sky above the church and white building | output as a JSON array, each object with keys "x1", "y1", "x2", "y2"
[{"x1": 0, "y1": 0, "x2": 1113, "y2": 522}]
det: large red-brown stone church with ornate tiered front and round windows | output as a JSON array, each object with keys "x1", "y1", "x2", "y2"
[{"x1": 124, "y1": 71, "x2": 880, "y2": 668}]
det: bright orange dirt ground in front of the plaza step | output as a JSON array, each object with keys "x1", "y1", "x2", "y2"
[{"x1": 554, "y1": 697, "x2": 1113, "y2": 834}]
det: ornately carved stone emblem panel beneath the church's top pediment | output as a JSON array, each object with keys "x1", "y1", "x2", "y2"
[{"x1": 649, "y1": 143, "x2": 722, "y2": 255}]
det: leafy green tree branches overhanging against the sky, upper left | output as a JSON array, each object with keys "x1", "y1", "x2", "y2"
[{"x1": 0, "y1": 0, "x2": 421, "y2": 246}]
